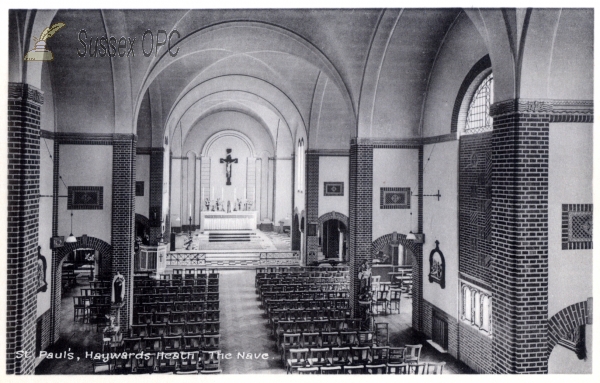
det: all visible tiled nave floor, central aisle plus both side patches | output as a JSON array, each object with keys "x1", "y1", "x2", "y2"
[{"x1": 36, "y1": 270, "x2": 473, "y2": 374}]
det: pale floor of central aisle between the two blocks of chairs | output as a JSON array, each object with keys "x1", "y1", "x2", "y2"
[{"x1": 219, "y1": 270, "x2": 285, "y2": 374}]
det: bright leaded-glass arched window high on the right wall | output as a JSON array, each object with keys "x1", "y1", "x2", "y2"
[{"x1": 462, "y1": 73, "x2": 494, "y2": 134}]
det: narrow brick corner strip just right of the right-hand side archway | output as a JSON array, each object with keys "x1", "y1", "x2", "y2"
[{"x1": 412, "y1": 145, "x2": 424, "y2": 331}]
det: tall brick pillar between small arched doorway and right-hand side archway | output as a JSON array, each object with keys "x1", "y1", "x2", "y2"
[{"x1": 348, "y1": 139, "x2": 373, "y2": 317}]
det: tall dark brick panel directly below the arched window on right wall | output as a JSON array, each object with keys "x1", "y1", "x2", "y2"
[{"x1": 458, "y1": 132, "x2": 492, "y2": 284}]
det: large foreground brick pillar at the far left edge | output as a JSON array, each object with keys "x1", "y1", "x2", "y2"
[{"x1": 6, "y1": 83, "x2": 44, "y2": 374}]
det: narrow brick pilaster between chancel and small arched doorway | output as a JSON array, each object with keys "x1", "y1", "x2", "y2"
[{"x1": 305, "y1": 153, "x2": 319, "y2": 264}]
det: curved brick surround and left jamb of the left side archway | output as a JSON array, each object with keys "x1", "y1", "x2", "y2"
[{"x1": 50, "y1": 237, "x2": 112, "y2": 343}]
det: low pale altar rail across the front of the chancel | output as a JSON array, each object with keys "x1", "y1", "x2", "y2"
[{"x1": 166, "y1": 251, "x2": 300, "y2": 267}]
